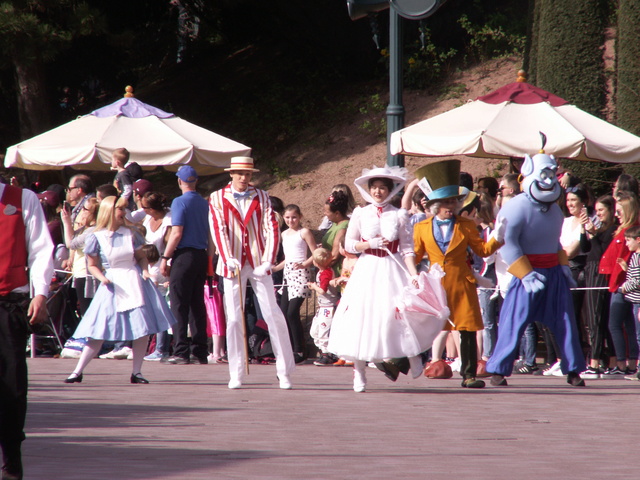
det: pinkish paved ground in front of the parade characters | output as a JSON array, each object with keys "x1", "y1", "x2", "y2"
[{"x1": 24, "y1": 358, "x2": 640, "y2": 480}]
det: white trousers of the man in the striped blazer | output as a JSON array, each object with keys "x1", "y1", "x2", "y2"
[{"x1": 223, "y1": 264, "x2": 296, "y2": 381}]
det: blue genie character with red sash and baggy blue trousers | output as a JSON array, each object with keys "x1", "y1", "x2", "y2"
[{"x1": 486, "y1": 142, "x2": 586, "y2": 386}]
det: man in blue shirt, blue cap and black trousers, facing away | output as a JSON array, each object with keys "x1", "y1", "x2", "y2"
[{"x1": 160, "y1": 165, "x2": 209, "y2": 365}]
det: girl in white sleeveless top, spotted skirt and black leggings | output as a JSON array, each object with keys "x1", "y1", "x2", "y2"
[{"x1": 273, "y1": 204, "x2": 316, "y2": 363}]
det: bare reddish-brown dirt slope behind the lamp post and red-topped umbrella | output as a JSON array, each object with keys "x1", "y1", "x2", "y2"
[{"x1": 255, "y1": 57, "x2": 521, "y2": 228}]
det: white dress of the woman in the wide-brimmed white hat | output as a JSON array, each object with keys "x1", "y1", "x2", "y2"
[{"x1": 328, "y1": 205, "x2": 443, "y2": 362}]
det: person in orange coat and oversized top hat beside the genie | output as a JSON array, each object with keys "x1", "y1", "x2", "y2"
[{"x1": 413, "y1": 160, "x2": 502, "y2": 388}]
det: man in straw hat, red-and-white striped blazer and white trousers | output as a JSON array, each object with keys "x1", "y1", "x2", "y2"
[{"x1": 209, "y1": 157, "x2": 295, "y2": 390}]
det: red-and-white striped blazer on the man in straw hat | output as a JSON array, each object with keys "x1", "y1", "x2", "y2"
[{"x1": 209, "y1": 184, "x2": 280, "y2": 277}]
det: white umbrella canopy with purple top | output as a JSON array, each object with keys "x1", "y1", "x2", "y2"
[{"x1": 5, "y1": 97, "x2": 251, "y2": 175}]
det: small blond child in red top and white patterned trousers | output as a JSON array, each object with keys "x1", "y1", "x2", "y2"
[{"x1": 307, "y1": 248, "x2": 338, "y2": 366}]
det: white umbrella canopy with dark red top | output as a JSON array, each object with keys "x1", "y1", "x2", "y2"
[{"x1": 390, "y1": 82, "x2": 640, "y2": 163}]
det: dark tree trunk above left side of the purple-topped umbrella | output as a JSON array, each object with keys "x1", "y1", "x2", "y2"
[{"x1": 14, "y1": 59, "x2": 51, "y2": 139}]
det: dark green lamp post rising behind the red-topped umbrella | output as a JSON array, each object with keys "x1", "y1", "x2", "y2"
[{"x1": 347, "y1": 0, "x2": 447, "y2": 167}]
